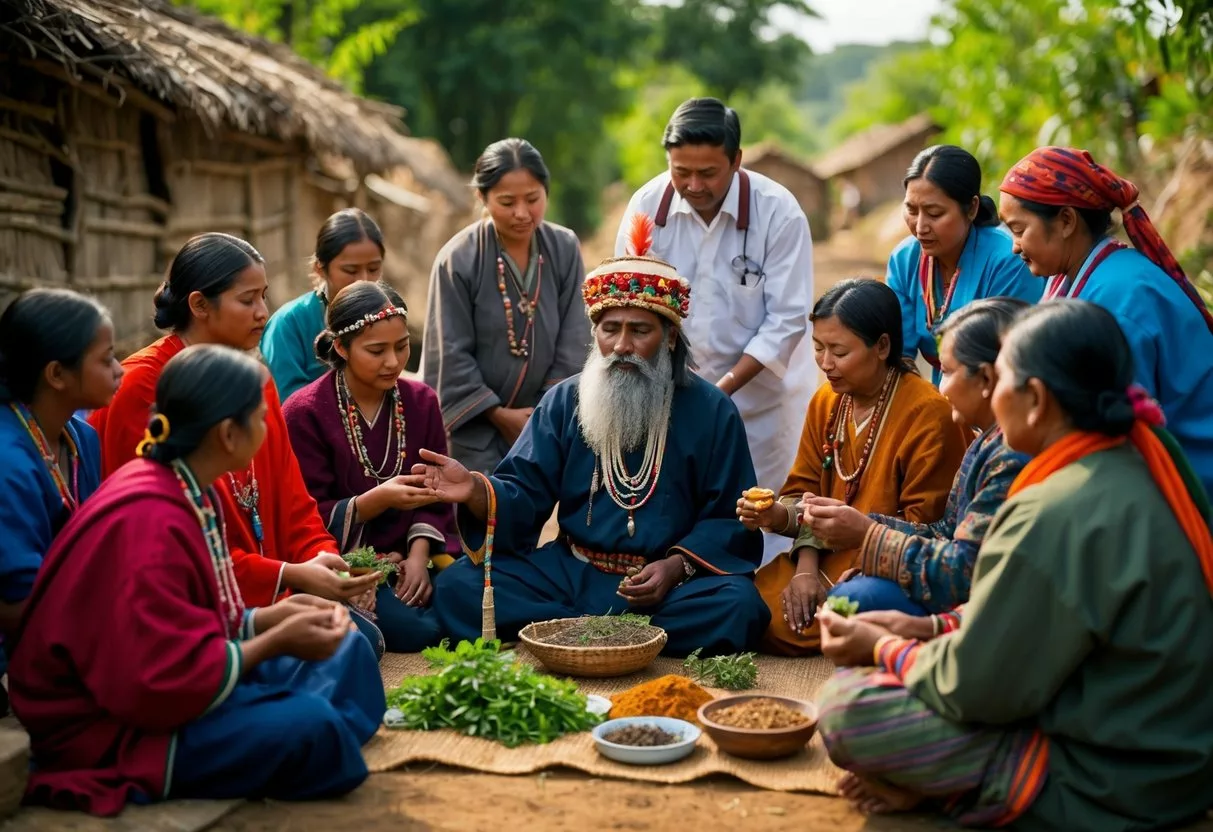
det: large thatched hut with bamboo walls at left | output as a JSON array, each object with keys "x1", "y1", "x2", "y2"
[{"x1": 0, "y1": 0, "x2": 470, "y2": 352}]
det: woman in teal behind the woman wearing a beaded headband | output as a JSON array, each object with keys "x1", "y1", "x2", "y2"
[{"x1": 261, "y1": 209, "x2": 386, "y2": 401}]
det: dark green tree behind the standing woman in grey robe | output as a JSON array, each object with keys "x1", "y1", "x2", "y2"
[{"x1": 356, "y1": 0, "x2": 654, "y2": 230}]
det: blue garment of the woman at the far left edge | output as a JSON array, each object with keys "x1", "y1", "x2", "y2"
[{"x1": 0, "y1": 403, "x2": 101, "y2": 674}]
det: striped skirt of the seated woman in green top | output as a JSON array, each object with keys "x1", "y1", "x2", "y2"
[{"x1": 818, "y1": 668, "x2": 1048, "y2": 826}]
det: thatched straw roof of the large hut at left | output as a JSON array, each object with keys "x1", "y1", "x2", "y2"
[{"x1": 0, "y1": 0, "x2": 406, "y2": 170}]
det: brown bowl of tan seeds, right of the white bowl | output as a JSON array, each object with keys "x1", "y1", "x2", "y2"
[{"x1": 699, "y1": 694, "x2": 818, "y2": 759}]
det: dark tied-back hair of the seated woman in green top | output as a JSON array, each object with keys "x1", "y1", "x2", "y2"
[{"x1": 1004, "y1": 300, "x2": 1134, "y2": 437}]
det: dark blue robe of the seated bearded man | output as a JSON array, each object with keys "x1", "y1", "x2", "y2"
[{"x1": 434, "y1": 376, "x2": 770, "y2": 655}]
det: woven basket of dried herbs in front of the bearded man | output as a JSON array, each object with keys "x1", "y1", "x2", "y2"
[{"x1": 518, "y1": 612, "x2": 666, "y2": 678}]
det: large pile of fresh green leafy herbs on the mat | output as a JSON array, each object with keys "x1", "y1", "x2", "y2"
[{"x1": 383, "y1": 638, "x2": 602, "y2": 748}]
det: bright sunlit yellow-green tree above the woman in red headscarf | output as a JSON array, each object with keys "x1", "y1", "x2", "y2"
[{"x1": 841, "y1": 0, "x2": 1157, "y2": 175}]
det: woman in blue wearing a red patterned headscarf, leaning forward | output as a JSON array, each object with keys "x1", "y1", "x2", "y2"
[{"x1": 1000, "y1": 147, "x2": 1213, "y2": 502}]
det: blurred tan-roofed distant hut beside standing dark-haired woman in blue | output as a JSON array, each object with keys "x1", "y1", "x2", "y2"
[{"x1": 813, "y1": 113, "x2": 941, "y2": 224}]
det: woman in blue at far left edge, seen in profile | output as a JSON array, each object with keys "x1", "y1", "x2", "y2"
[{"x1": 0, "y1": 289, "x2": 123, "y2": 693}]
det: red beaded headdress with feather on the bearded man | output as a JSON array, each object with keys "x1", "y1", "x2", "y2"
[{"x1": 581, "y1": 212, "x2": 690, "y2": 326}]
